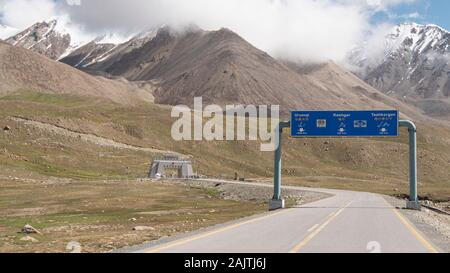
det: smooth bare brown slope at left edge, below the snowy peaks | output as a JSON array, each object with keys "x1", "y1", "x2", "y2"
[{"x1": 0, "y1": 42, "x2": 153, "y2": 104}]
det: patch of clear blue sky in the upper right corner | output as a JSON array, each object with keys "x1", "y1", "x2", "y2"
[{"x1": 374, "y1": 0, "x2": 450, "y2": 30}]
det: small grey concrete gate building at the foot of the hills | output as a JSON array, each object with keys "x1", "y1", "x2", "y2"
[{"x1": 149, "y1": 155, "x2": 195, "y2": 179}]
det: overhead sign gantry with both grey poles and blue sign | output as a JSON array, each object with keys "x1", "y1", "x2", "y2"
[{"x1": 269, "y1": 110, "x2": 420, "y2": 210}]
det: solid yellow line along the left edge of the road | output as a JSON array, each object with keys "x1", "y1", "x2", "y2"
[{"x1": 144, "y1": 209, "x2": 292, "y2": 253}]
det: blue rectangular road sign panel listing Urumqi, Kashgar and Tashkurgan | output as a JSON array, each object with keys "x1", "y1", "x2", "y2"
[{"x1": 291, "y1": 110, "x2": 399, "y2": 138}]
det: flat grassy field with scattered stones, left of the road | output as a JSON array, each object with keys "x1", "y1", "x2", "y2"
[{"x1": 0, "y1": 178, "x2": 266, "y2": 252}]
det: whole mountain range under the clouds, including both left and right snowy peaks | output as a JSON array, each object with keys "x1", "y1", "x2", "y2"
[{"x1": 0, "y1": 20, "x2": 450, "y2": 119}]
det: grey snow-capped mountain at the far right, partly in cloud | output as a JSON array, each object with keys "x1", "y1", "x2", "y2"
[{"x1": 348, "y1": 23, "x2": 450, "y2": 116}]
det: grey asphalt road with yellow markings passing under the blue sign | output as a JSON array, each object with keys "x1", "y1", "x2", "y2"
[{"x1": 126, "y1": 182, "x2": 438, "y2": 253}]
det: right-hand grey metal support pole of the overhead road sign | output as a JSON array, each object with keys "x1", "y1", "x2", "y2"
[{"x1": 399, "y1": 120, "x2": 420, "y2": 210}]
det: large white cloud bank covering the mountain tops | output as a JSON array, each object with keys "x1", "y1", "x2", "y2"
[{"x1": 0, "y1": 0, "x2": 422, "y2": 61}]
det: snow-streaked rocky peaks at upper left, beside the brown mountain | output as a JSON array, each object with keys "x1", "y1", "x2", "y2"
[{"x1": 0, "y1": 17, "x2": 157, "y2": 68}]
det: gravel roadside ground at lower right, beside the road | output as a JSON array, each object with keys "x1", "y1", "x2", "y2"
[{"x1": 385, "y1": 196, "x2": 450, "y2": 253}]
